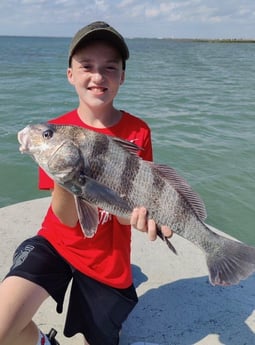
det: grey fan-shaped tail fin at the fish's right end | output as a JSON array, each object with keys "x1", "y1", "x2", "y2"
[{"x1": 207, "y1": 237, "x2": 255, "y2": 286}]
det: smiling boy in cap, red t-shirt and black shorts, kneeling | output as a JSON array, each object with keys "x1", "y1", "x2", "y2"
[{"x1": 0, "y1": 22, "x2": 171, "y2": 345}]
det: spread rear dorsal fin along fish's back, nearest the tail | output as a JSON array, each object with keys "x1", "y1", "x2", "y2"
[{"x1": 151, "y1": 163, "x2": 207, "y2": 221}]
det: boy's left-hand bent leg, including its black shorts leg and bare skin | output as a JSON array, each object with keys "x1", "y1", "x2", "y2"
[{"x1": 0, "y1": 236, "x2": 72, "y2": 345}]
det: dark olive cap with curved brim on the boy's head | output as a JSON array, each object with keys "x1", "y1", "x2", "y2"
[{"x1": 68, "y1": 21, "x2": 129, "y2": 66}]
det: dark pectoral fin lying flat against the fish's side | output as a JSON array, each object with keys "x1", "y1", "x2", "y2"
[{"x1": 81, "y1": 176, "x2": 132, "y2": 213}]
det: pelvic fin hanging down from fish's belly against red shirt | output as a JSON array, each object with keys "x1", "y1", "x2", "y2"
[{"x1": 75, "y1": 197, "x2": 98, "y2": 238}]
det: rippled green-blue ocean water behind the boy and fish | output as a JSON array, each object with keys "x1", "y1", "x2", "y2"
[{"x1": 0, "y1": 37, "x2": 255, "y2": 245}]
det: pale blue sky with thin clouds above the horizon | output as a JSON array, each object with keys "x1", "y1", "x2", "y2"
[{"x1": 0, "y1": 0, "x2": 255, "y2": 39}]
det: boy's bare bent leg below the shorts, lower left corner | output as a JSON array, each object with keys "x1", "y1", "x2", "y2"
[{"x1": 0, "y1": 276, "x2": 49, "y2": 345}]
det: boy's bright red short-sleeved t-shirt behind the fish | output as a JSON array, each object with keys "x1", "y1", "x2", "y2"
[{"x1": 38, "y1": 110, "x2": 152, "y2": 288}]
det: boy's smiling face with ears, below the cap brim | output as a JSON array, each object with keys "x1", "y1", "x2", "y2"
[{"x1": 67, "y1": 41, "x2": 125, "y2": 108}]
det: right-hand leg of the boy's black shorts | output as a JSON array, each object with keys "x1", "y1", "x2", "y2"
[{"x1": 64, "y1": 271, "x2": 137, "y2": 345}]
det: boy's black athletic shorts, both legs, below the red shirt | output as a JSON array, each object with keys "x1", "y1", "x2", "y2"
[{"x1": 7, "y1": 236, "x2": 137, "y2": 345}]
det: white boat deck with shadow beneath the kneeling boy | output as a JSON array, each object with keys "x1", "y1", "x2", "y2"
[{"x1": 0, "y1": 198, "x2": 255, "y2": 345}]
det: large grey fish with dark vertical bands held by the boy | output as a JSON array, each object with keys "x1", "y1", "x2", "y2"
[{"x1": 18, "y1": 123, "x2": 255, "y2": 286}]
